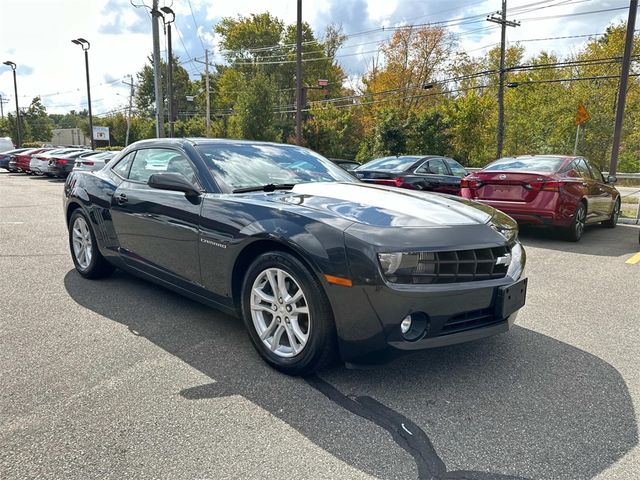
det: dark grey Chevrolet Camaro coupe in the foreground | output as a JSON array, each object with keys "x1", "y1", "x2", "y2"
[{"x1": 64, "y1": 139, "x2": 526, "y2": 375}]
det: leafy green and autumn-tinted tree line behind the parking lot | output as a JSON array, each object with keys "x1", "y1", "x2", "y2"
[{"x1": 0, "y1": 18, "x2": 640, "y2": 171}]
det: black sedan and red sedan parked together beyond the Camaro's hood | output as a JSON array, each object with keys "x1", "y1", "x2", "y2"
[{"x1": 353, "y1": 155, "x2": 620, "y2": 241}]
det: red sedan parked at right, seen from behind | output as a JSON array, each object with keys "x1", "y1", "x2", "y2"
[{"x1": 460, "y1": 155, "x2": 620, "y2": 241}]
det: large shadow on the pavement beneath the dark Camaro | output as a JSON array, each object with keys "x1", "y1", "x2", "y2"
[{"x1": 64, "y1": 270, "x2": 638, "y2": 480}]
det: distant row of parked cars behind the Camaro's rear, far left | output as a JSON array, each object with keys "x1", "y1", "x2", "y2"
[{"x1": 0, "y1": 147, "x2": 117, "y2": 177}]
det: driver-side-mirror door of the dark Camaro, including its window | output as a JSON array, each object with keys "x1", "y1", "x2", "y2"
[{"x1": 111, "y1": 148, "x2": 202, "y2": 285}]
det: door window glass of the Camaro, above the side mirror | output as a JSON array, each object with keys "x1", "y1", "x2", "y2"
[{"x1": 129, "y1": 148, "x2": 198, "y2": 185}]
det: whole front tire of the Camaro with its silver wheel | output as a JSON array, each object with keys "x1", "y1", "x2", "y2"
[{"x1": 242, "y1": 252, "x2": 336, "y2": 375}]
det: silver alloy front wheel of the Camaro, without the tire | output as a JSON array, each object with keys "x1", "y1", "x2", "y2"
[{"x1": 250, "y1": 268, "x2": 311, "y2": 358}]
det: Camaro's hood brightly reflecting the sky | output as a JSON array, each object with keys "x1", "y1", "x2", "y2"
[{"x1": 240, "y1": 183, "x2": 497, "y2": 228}]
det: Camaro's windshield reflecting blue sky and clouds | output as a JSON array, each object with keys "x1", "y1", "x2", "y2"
[{"x1": 197, "y1": 143, "x2": 357, "y2": 190}]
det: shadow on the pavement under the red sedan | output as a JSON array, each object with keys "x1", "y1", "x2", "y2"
[{"x1": 520, "y1": 224, "x2": 640, "y2": 257}]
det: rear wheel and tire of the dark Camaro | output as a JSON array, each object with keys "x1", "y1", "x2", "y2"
[{"x1": 69, "y1": 208, "x2": 115, "y2": 279}]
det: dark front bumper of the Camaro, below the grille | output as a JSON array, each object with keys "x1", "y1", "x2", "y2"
[{"x1": 328, "y1": 243, "x2": 525, "y2": 363}]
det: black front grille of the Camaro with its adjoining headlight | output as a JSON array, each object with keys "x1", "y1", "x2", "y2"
[{"x1": 391, "y1": 246, "x2": 511, "y2": 284}]
